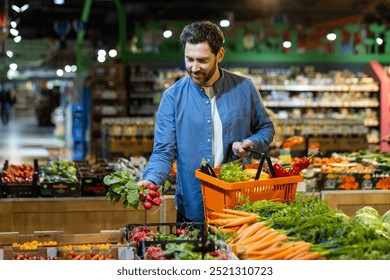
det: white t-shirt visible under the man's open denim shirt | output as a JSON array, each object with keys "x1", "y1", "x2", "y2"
[{"x1": 203, "y1": 87, "x2": 223, "y2": 167}]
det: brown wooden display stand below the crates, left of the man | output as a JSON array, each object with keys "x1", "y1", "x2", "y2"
[{"x1": 0, "y1": 196, "x2": 176, "y2": 234}]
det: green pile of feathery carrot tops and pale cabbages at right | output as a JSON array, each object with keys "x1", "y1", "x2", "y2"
[{"x1": 236, "y1": 193, "x2": 390, "y2": 260}]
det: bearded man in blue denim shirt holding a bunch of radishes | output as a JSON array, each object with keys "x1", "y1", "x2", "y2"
[{"x1": 138, "y1": 21, "x2": 275, "y2": 222}]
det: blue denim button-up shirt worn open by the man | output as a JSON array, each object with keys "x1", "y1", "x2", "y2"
[{"x1": 143, "y1": 69, "x2": 275, "y2": 222}]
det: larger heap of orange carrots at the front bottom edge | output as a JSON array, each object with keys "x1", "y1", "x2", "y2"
[{"x1": 227, "y1": 222, "x2": 321, "y2": 260}]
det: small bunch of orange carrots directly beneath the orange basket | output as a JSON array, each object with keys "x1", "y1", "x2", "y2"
[{"x1": 207, "y1": 208, "x2": 259, "y2": 234}]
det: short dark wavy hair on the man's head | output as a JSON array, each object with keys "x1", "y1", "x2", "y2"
[{"x1": 180, "y1": 21, "x2": 225, "y2": 55}]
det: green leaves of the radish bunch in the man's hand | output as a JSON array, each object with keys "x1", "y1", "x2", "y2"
[{"x1": 103, "y1": 169, "x2": 142, "y2": 209}]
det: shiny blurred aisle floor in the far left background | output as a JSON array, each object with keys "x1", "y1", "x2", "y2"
[{"x1": 0, "y1": 111, "x2": 71, "y2": 168}]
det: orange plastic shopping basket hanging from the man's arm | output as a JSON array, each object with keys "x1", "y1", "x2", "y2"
[{"x1": 195, "y1": 164, "x2": 303, "y2": 215}]
